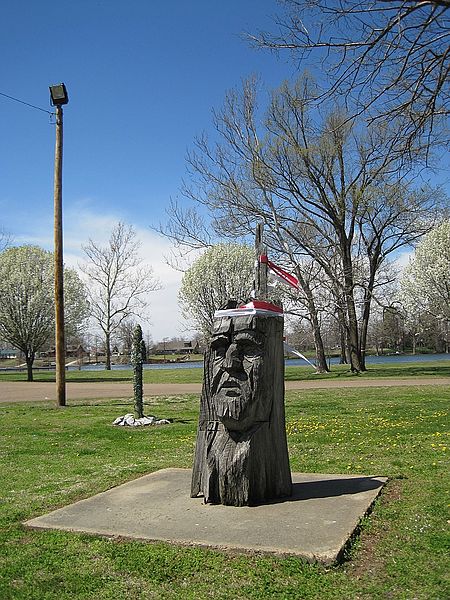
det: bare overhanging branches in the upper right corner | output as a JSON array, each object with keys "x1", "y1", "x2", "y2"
[{"x1": 250, "y1": 0, "x2": 450, "y2": 154}]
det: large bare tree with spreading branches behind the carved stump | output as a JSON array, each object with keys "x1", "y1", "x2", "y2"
[{"x1": 163, "y1": 78, "x2": 439, "y2": 371}]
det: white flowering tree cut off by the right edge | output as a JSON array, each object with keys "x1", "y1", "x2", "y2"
[{"x1": 401, "y1": 220, "x2": 450, "y2": 351}]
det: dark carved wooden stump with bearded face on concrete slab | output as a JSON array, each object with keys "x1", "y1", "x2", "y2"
[{"x1": 191, "y1": 316, "x2": 292, "y2": 506}]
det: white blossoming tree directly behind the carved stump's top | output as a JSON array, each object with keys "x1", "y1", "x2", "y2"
[{"x1": 178, "y1": 244, "x2": 255, "y2": 335}]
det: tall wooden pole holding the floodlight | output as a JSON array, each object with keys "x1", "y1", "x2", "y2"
[{"x1": 54, "y1": 106, "x2": 66, "y2": 406}]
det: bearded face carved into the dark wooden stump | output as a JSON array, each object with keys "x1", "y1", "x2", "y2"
[{"x1": 211, "y1": 319, "x2": 271, "y2": 432}]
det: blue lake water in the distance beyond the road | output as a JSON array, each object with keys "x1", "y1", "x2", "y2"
[{"x1": 68, "y1": 354, "x2": 450, "y2": 371}]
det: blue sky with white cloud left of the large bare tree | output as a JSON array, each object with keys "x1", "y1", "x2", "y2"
[{"x1": 0, "y1": 0, "x2": 448, "y2": 340}]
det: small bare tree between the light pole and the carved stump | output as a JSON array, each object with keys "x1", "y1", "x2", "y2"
[{"x1": 80, "y1": 222, "x2": 160, "y2": 370}]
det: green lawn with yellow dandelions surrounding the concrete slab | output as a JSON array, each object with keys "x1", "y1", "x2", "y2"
[{"x1": 0, "y1": 386, "x2": 450, "y2": 600}]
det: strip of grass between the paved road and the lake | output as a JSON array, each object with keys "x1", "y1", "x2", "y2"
[{"x1": 0, "y1": 360, "x2": 450, "y2": 383}]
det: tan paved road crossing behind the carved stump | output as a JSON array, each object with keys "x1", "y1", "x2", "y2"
[{"x1": 0, "y1": 377, "x2": 450, "y2": 403}]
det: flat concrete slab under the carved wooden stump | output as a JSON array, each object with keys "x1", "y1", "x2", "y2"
[{"x1": 25, "y1": 469, "x2": 387, "y2": 564}]
